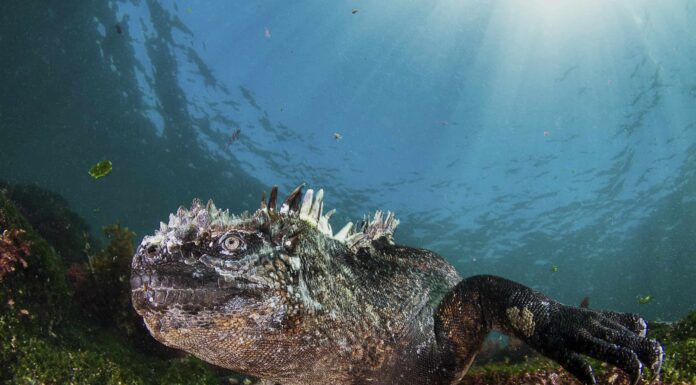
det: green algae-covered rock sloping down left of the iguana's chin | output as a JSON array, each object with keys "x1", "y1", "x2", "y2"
[{"x1": 0, "y1": 185, "x2": 221, "y2": 385}]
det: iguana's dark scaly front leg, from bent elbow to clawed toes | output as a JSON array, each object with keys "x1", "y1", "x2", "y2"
[{"x1": 435, "y1": 276, "x2": 664, "y2": 384}]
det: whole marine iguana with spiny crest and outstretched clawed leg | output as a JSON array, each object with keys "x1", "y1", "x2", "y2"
[{"x1": 131, "y1": 185, "x2": 664, "y2": 385}]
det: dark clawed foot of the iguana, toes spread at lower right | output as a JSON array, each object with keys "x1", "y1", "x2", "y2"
[{"x1": 529, "y1": 305, "x2": 664, "y2": 384}]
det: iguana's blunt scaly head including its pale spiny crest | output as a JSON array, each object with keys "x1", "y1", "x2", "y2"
[{"x1": 131, "y1": 186, "x2": 398, "y2": 370}]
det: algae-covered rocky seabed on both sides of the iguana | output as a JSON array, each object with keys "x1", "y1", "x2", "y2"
[{"x1": 0, "y1": 185, "x2": 696, "y2": 385}]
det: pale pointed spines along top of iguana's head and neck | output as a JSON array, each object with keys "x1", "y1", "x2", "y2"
[{"x1": 159, "y1": 185, "x2": 399, "y2": 249}]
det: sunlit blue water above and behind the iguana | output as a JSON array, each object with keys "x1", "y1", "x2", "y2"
[{"x1": 0, "y1": 0, "x2": 696, "y2": 320}]
